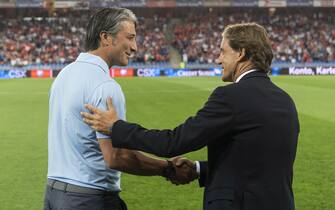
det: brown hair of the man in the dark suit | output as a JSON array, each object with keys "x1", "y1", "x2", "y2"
[{"x1": 222, "y1": 23, "x2": 273, "y2": 72}]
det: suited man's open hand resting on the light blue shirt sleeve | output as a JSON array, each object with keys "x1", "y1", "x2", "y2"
[{"x1": 80, "y1": 98, "x2": 119, "y2": 135}]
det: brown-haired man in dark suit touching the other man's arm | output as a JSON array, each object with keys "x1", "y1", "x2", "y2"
[{"x1": 82, "y1": 23, "x2": 299, "y2": 210}]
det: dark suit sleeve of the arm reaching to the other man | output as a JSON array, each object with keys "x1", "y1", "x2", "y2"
[{"x1": 111, "y1": 87, "x2": 233, "y2": 157}]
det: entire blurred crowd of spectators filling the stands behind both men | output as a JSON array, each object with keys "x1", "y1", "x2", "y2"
[{"x1": 0, "y1": 9, "x2": 335, "y2": 66}]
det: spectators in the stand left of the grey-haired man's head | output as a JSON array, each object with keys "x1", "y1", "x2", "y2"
[{"x1": 0, "y1": 18, "x2": 86, "y2": 66}]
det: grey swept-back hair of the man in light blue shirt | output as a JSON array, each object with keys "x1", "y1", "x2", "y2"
[{"x1": 85, "y1": 7, "x2": 137, "y2": 51}]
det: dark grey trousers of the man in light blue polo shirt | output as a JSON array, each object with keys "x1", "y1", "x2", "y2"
[{"x1": 44, "y1": 186, "x2": 127, "y2": 210}]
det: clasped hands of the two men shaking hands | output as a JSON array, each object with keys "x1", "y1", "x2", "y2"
[{"x1": 163, "y1": 157, "x2": 199, "y2": 185}]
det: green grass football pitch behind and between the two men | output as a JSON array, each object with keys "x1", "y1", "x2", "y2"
[{"x1": 0, "y1": 76, "x2": 335, "y2": 210}]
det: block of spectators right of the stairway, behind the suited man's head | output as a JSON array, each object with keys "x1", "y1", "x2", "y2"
[{"x1": 173, "y1": 13, "x2": 335, "y2": 63}]
